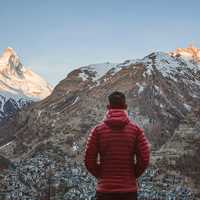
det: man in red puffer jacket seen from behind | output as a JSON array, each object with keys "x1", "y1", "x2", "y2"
[{"x1": 84, "y1": 91, "x2": 150, "y2": 200}]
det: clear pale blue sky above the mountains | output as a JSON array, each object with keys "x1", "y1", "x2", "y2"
[{"x1": 0, "y1": 0, "x2": 200, "y2": 86}]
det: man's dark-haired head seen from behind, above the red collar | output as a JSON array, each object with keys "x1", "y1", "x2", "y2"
[{"x1": 107, "y1": 91, "x2": 127, "y2": 109}]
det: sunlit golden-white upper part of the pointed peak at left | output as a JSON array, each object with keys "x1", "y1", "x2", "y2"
[{"x1": 0, "y1": 47, "x2": 52, "y2": 99}]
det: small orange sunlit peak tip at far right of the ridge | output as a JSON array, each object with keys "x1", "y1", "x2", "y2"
[{"x1": 170, "y1": 44, "x2": 200, "y2": 63}]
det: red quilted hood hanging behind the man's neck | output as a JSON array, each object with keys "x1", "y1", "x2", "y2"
[{"x1": 103, "y1": 109, "x2": 129, "y2": 129}]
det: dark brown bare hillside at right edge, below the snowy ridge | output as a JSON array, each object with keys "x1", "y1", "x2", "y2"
[{"x1": 154, "y1": 109, "x2": 200, "y2": 197}]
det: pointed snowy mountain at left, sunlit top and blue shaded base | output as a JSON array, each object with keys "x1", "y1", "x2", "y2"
[{"x1": 0, "y1": 48, "x2": 52, "y2": 121}]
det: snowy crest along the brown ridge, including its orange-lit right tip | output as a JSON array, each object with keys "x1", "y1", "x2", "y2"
[{"x1": 69, "y1": 46, "x2": 200, "y2": 86}]
